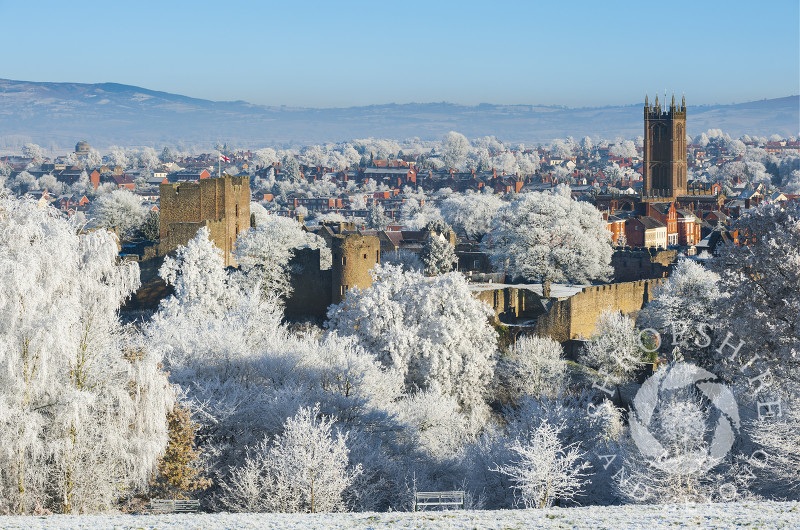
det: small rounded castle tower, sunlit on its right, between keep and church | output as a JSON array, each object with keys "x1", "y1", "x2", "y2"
[{"x1": 331, "y1": 234, "x2": 381, "y2": 304}]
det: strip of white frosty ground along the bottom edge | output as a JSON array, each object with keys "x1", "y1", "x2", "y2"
[{"x1": 0, "y1": 502, "x2": 800, "y2": 530}]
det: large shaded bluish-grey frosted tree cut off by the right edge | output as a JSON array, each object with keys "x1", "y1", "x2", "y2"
[{"x1": 711, "y1": 204, "x2": 800, "y2": 386}]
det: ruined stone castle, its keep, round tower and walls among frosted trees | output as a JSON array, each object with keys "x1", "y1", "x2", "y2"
[{"x1": 128, "y1": 176, "x2": 663, "y2": 342}]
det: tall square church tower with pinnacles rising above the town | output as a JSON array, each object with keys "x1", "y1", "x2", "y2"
[{"x1": 642, "y1": 95, "x2": 686, "y2": 201}]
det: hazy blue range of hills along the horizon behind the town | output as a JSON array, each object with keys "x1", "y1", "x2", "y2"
[{"x1": 0, "y1": 79, "x2": 800, "y2": 152}]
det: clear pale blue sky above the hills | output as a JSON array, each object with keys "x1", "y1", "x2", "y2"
[{"x1": 0, "y1": 0, "x2": 800, "y2": 107}]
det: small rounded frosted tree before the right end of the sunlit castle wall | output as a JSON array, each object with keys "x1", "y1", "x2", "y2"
[{"x1": 581, "y1": 311, "x2": 644, "y2": 385}]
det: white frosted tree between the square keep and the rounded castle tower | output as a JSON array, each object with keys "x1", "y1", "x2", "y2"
[{"x1": 235, "y1": 215, "x2": 331, "y2": 296}]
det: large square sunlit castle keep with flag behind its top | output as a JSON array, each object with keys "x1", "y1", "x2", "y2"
[{"x1": 158, "y1": 175, "x2": 250, "y2": 266}]
